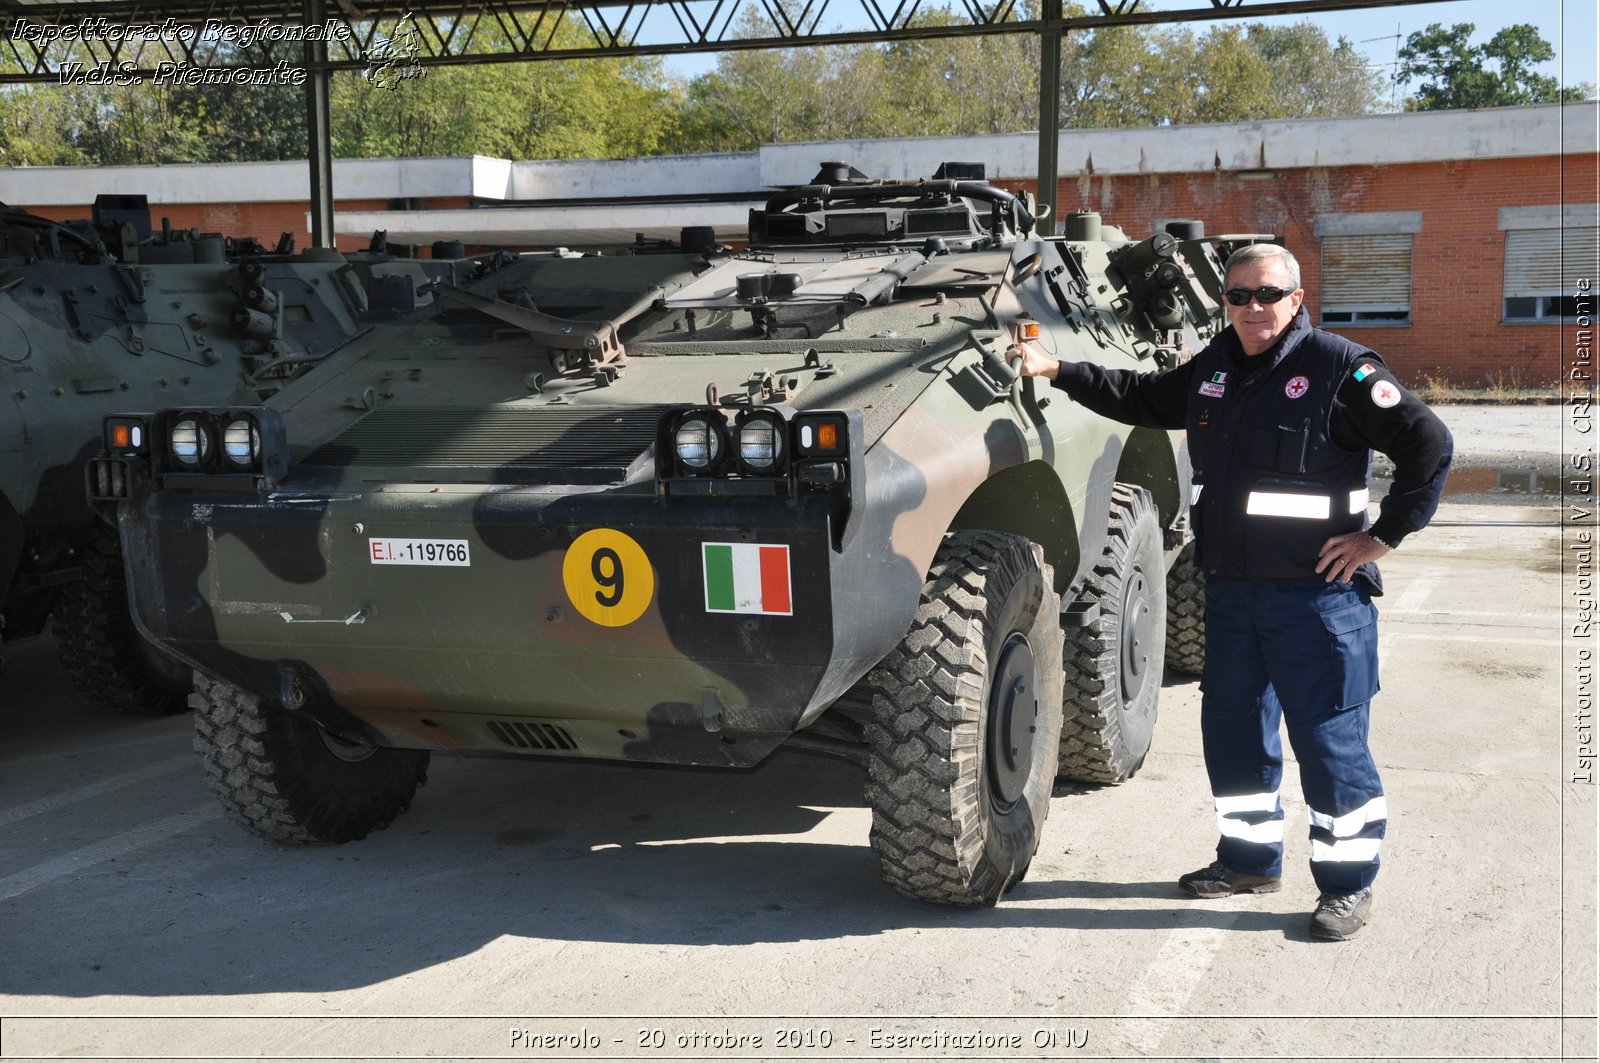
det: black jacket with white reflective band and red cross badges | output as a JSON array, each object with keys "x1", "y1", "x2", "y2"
[{"x1": 1054, "y1": 309, "x2": 1453, "y2": 584}]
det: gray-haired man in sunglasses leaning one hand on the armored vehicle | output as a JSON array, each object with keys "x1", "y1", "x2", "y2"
[{"x1": 1006, "y1": 243, "x2": 1453, "y2": 941}]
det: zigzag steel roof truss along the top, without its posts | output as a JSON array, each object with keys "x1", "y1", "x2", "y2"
[{"x1": 0, "y1": 0, "x2": 1440, "y2": 83}]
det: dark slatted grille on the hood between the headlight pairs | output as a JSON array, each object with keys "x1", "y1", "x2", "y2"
[{"x1": 302, "y1": 405, "x2": 666, "y2": 483}]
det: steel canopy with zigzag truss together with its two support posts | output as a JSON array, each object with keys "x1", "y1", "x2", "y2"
[{"x1": 0, "y1": 0, "x2": 1438, "y2": 247}]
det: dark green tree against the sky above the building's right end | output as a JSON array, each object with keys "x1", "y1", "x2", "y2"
[{"x1": 1395, "y1": 22, "x2": 1594, "y2": 110}]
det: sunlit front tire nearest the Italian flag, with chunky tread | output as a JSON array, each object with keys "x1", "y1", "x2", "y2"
[{"x1": 864, "y1": 532, "x2": 1061, "y2": 906}]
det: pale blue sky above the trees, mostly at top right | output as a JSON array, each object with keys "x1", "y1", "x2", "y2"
[{"x1": 667, "y1": 0, "x2": 1600, "y2": 94}]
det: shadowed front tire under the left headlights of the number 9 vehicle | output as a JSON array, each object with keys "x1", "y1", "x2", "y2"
[{"x1": 189, "y1": 672, "x2": 427, "y2": 844}]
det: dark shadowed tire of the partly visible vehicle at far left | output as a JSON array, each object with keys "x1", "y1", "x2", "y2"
[{"x1": 51, "y1": 523, "x2": 192, "y2": 716}]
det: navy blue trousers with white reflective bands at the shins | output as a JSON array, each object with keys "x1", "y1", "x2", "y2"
[{"x1": 1200, "y1": 580, "x2": 1389, "y2": 893}]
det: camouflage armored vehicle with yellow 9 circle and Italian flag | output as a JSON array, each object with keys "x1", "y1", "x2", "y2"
[{"x1": 91, "y1": 166, "x2": 1222, "y2": 905}]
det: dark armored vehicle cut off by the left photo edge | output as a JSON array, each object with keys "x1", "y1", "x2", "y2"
[{"x1": 0, "y1": 195, "x2": 460, "y2": 714}]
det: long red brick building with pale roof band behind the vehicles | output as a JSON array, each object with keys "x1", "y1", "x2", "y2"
[{"x1": 0, "y1": 101, "x2": 1600, "y2": 386}]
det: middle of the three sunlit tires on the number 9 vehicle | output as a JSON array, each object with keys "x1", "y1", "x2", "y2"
[{"x1": 1058, "y1": 483, "x2": 1166, "y2": 783}]
